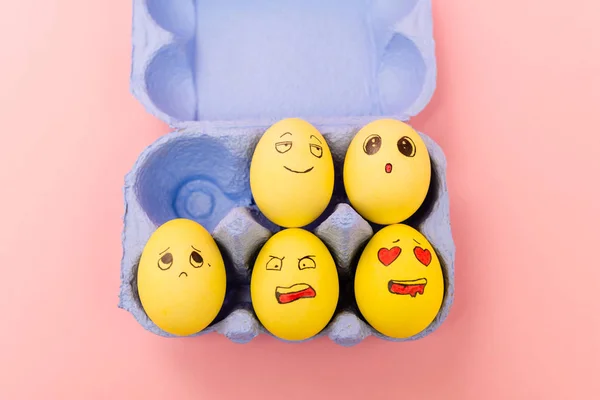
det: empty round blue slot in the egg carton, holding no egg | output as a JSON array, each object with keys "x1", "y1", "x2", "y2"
[{"x1": 135, "y1": 135, "x2": 250, "y2": 232}]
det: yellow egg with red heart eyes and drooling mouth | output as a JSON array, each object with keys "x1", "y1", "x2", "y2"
[{"x1": 354, "y1": 224, "x2": 444, "y2": 339}]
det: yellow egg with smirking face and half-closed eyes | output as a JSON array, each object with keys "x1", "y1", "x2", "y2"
[{"x1": 250, "y1": 118, "x2": 334, "y2": 228}]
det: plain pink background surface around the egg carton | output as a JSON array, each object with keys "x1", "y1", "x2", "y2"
[{"x1": 0, "y1": 0, "x2": 600, "y2": 399}]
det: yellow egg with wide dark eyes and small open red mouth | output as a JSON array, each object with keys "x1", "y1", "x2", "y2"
[{"x1": 344, "y1": 119, "x2": 431, "y2": 225}]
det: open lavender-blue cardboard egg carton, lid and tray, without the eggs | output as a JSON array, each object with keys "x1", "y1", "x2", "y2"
[{"x1": 119, "y1": 0, "x2": 455, "y2": 346}]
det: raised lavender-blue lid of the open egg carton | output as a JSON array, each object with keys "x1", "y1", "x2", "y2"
[{"x1": 131, "y1": 0, "x2": 436, "y2": 130}]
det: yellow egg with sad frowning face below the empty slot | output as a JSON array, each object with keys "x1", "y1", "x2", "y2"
[{"x1": 137, "y1": 219, "x2": 226, "y2": 336}]
